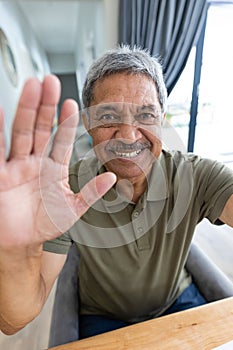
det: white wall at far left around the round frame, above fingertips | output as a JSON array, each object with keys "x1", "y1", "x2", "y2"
[{"x1": 0, "y1": 1, "x2": 50, "y2": 154}]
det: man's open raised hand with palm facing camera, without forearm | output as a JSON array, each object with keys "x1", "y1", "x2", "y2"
[{"x1": 0, "y1": 75, "x2": 115, "y2": 249}]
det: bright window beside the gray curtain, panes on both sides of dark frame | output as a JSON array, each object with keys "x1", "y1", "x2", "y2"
[{"x1": 168, "y1": 2, "x2": 233, "y2": 167}]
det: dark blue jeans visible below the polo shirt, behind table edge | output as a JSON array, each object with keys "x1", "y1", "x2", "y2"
[{"x1": 79, "y1": 283, "x2": 206, "y2": 339}]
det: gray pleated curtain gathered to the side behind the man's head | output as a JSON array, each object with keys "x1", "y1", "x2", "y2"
[{"x1": 119, "y1": 0, "x2": 208, "y2": 93}]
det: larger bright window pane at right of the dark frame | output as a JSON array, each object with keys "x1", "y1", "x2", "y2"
[{"x1": 194, "y1": 4, "x2": 233, "y2": 167}]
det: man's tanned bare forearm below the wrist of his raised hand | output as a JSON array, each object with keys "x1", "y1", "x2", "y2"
[{"x1": 0, "y1": 250, "x2": 66, "y2": 335}]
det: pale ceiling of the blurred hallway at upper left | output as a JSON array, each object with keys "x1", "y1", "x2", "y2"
[{"x1": 17, "y1": 0, "x2": 104, "y2": 53}]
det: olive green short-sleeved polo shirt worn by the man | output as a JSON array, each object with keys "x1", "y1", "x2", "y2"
[{"x1": 44, "y1": 151, "x2": 233, "y2": 322}]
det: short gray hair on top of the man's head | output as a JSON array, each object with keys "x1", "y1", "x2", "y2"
[{"x1": 82, "y1": 45, "x2": 167, "y2": 112}]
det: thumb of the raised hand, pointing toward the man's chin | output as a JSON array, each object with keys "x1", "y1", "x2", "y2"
[{"x1": 76, "y1": 172, "x2": 116, "y2": 218}]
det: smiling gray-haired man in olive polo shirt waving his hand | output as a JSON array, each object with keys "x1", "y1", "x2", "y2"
[{"x1": 0, "y1": 47, "x2": 233, "y2": 338}]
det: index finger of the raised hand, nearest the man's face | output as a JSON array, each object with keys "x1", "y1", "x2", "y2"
[{"x1": 50, "y1": 99, "x2": 79, "y2": 165}]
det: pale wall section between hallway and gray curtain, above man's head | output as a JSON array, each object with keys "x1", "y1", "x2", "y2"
[{"x1": 75, "y1": 0, "x2": 119, "y2": 88}]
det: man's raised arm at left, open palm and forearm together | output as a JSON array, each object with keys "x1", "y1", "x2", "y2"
[{"x1": 0, "y1": 76, "x2": 116, "y2": 334}]
